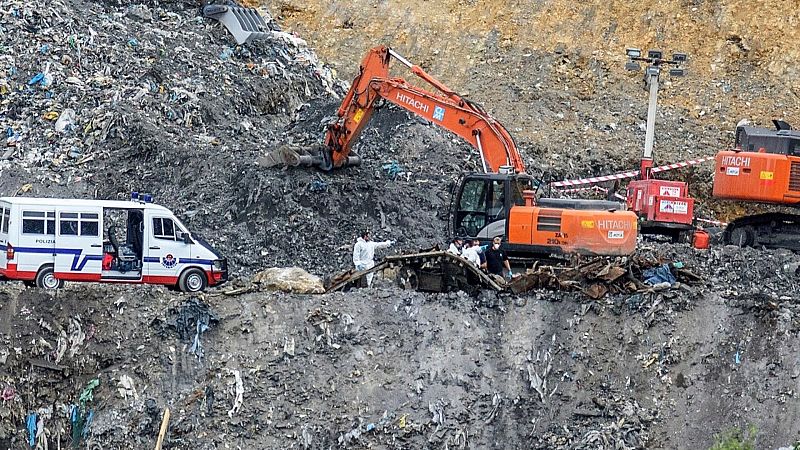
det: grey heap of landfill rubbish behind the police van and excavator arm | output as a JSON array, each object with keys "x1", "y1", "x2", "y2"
[{"x1": 0, "y1": 1, "x2": 479, "y2": 274}]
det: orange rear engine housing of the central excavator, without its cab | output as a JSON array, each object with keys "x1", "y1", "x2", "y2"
[{"x1": 508, "y1": 206, "x2": 638, "y2": 256}]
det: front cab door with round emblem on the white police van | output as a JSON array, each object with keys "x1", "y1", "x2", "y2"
[{"x1": 144, "y1": 211, "x2": 191, "y2": 285}]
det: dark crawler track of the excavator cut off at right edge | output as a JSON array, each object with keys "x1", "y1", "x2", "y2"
[{"x1": 723, "y1": 213, "x2": 800, "y2": 251}]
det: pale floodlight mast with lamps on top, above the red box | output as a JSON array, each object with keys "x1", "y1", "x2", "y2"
[{"x1": 625, "y1": 48, "x2": 687, "y2": 180}]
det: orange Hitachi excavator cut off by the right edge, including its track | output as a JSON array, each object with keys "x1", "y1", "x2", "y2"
[{"x1": 713, "y1": 120, "x2": 800, "y2": 250}]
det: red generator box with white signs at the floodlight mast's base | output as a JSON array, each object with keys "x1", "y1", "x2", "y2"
[{"x1": 627, "y1": 179, "x2": 694, "y2": 225}]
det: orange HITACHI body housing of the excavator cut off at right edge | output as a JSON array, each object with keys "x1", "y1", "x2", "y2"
[{"x1": 714, "y1": 150, "x2": 800, "y2": 204}]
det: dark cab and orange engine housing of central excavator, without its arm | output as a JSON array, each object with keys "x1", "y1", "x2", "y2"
[{"x1": 451, "y1": 173, "x2": 638, "y2": 257}]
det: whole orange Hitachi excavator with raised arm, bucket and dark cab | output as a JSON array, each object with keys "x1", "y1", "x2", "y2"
[{"x1": 274, "y1": 46, "x2": 638, "y2": 257}]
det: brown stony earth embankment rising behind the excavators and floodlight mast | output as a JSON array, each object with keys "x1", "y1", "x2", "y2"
[{"x1": 261, "y1": 0, "x2": 800, "y2": 209}]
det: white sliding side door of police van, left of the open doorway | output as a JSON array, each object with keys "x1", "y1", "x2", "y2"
[{"x1": 55, "y1": 206, "x2": 103, "y2": 281}]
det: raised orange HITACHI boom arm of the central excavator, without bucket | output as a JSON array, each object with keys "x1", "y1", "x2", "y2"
[{"x1": 325, "y1": 46, "x2": 525, "y2": 172}]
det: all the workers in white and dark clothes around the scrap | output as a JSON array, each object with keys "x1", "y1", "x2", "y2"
[{"x1": 353, "y1": 231, "x2": 512, "y2": 287}]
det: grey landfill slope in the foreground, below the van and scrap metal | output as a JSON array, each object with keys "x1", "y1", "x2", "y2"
[{"x1": 0, "y1": 246, "x2": 800, "y2": 449}]
